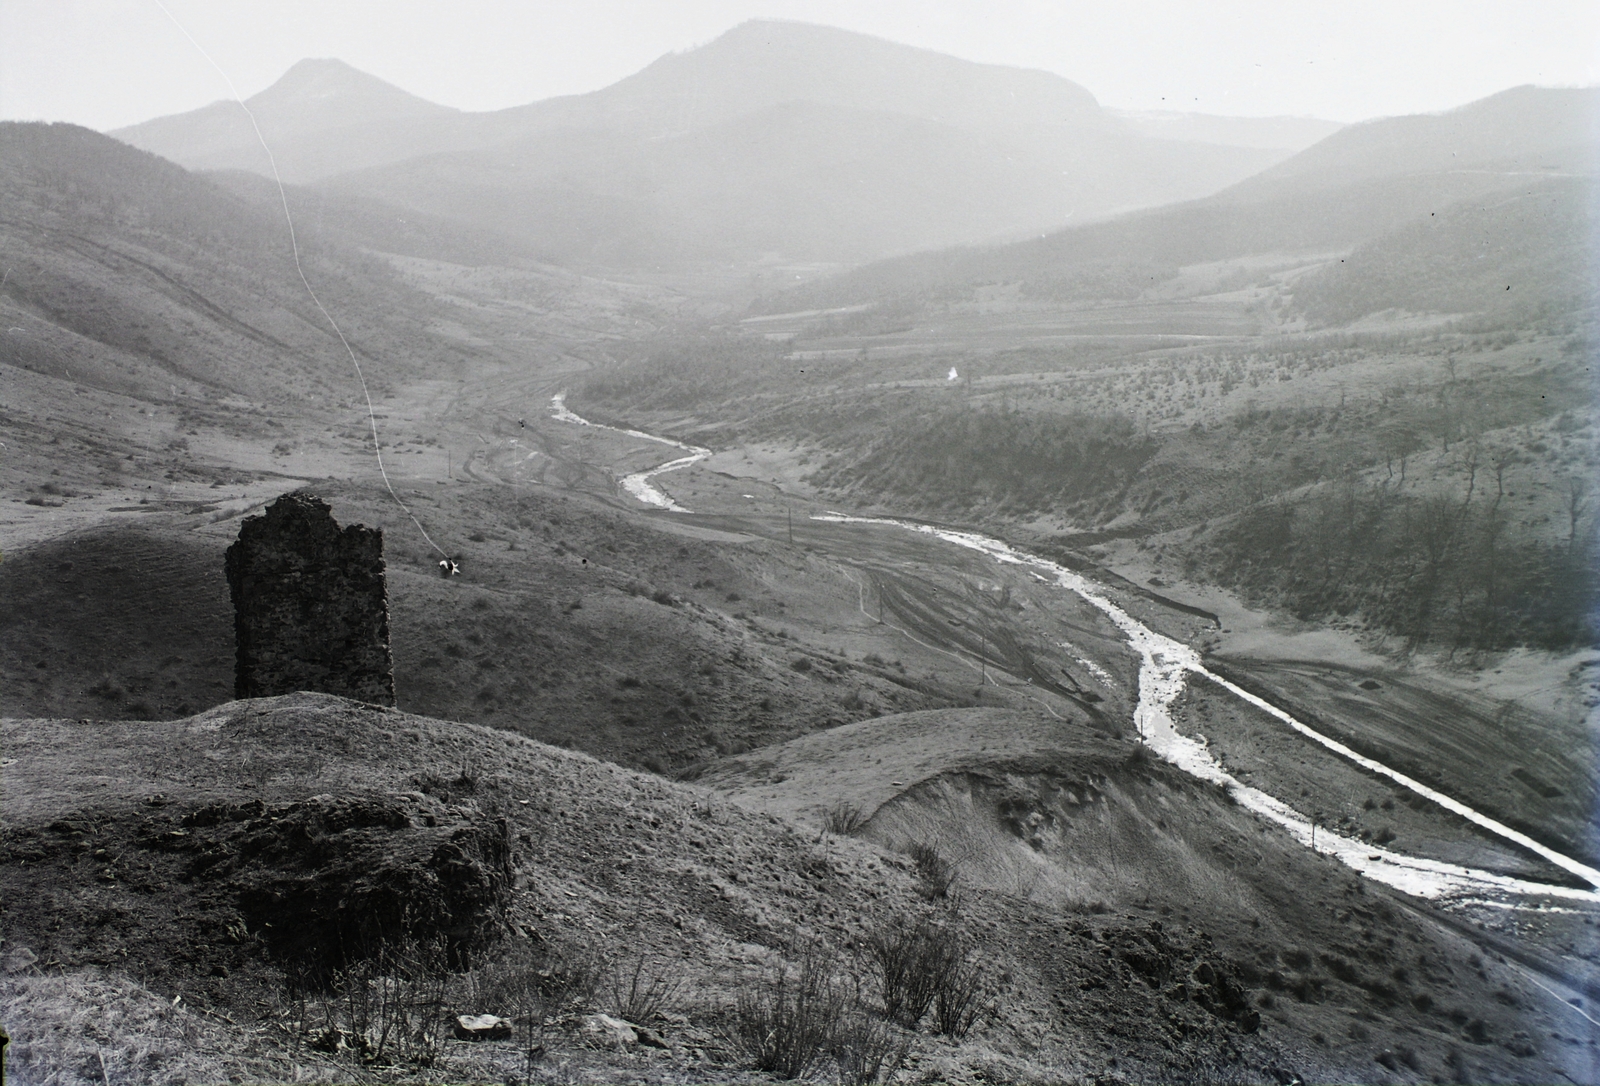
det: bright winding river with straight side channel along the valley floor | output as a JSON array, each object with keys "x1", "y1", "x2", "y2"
[{"x1": 550, "y1": 392, "x2": 1600, "y2": 908}]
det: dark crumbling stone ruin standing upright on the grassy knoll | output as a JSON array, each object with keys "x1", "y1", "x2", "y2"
[{"x1": 227, "y1": 493, "x2": 395, "y2": 705}]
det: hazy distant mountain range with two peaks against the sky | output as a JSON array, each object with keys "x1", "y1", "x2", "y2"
[{"x1": 112, "y1": 21, "x2": 1324, "y2": 270}]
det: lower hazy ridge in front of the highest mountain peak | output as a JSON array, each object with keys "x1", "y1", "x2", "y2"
[{"x1": 325, "y1": 101, "x2": 1280, "y2": 264}]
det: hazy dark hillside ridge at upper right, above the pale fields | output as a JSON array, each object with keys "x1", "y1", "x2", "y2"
[{"x1": 755, "y1": 88, "x2": 1600, "y2": 313}]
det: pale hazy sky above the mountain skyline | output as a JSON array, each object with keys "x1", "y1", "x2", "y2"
[{"x1": 0, "y1": 0, "x2": 1600, "y2": 128}]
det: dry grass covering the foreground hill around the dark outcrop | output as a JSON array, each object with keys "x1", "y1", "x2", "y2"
[{"x1": 0, "y1": 696, "x2": 1576, "y2": 1086}]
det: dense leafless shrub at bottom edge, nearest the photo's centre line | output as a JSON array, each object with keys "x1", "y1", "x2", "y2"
[{"x1": 731, "y1": 944, "x2": 848, "y2": 1078}]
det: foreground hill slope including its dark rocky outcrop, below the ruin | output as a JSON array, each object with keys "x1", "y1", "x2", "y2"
[{"x1": 9, "y1": 694, "x2": 1589, "y2": 1083}]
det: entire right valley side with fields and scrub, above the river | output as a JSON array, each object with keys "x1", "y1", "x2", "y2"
[{"x1": 573, "y1": 88, "x2": 1600, "y2": 654}]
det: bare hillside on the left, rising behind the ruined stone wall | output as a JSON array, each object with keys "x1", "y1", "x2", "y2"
[{"x1": 0, "y1": 123, "x2": 688, "y2": 549}]
